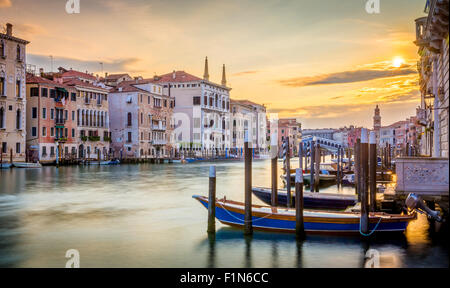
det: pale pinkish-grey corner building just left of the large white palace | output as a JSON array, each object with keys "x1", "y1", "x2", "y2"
[{"x1": 109, "y1": 80, "x2": 175, "y2": 159}]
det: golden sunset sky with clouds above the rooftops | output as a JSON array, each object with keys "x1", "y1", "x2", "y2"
[{"x1": 0, "y1": 0, "x2": 426, "y2": 128}]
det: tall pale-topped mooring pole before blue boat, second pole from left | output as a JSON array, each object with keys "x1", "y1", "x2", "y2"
[{"x1": 244, "y1": 131, "x2": 253, "y2": 235}]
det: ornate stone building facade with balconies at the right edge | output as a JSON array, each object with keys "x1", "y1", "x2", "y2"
[{"x1": 415, "y1": 0, "x2": 449, "y2": 158}]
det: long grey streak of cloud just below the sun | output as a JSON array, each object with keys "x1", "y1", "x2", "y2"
[{"x1": 278, "y1": 61, "x2": 417, "y2": 87}]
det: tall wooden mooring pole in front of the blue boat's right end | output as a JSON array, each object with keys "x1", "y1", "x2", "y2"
[{"x1": 360, "y1": 128, "x2": 369, "y2": 234}]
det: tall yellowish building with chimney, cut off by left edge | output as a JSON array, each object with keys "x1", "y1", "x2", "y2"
[{"x1": 0, "y1": 24, "x2": 29, "y2": 162}]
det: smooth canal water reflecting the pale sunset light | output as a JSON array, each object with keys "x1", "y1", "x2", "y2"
[{"x1": 0, "y1": 161, "x2": 449, "y2": 268}]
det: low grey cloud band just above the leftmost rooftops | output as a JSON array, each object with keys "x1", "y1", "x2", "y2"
[{"x1": 27, "y1": 54, "x2": 141, "y2": 73}]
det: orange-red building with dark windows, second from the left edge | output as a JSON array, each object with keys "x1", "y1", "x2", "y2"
[{"x1": 26, "y1": 73, "x2": 77, "y2": 163}]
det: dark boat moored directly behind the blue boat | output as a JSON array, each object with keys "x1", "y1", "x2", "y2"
[{"x1": 252, "y1": 188, "x2": 358, "y2": 210}]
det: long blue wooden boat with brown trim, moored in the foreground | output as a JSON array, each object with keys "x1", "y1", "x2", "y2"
[{"x1": 193, "y1": 196, "x2": 416, "y2": 234}]
